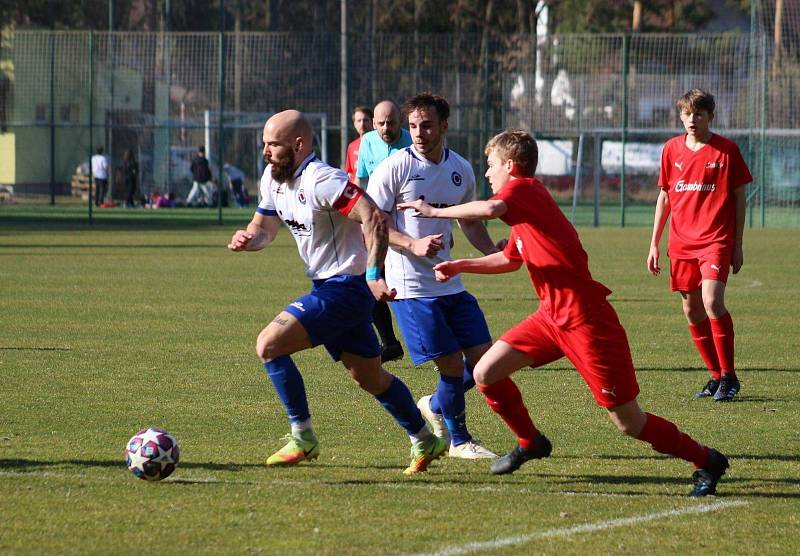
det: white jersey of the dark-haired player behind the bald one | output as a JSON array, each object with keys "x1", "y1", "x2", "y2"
[{"x1": 367, "y1": 146, "x2": 475, "y2": 299}]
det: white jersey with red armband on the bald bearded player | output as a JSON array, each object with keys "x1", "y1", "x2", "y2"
[{"x1": 256, "y1": 154, "x2": 367, "y2": 280}]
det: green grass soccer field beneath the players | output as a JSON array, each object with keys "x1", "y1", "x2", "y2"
[{"x1": 0, "y1": 209, "x2": 800, "y2": 554}]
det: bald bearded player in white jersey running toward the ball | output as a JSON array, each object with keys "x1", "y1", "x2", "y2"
[{"x1": 228, "y1": 110, "x2": 447, "y2": 475}]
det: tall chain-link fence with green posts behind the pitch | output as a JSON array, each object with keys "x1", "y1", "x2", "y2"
[{"x1": 0, "y1": 3, "x2": 800, "y2": 226}]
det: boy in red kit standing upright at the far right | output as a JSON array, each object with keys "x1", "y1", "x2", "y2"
[{"x1": 647, "y1": 89, "x2": 753, "y2": 402}]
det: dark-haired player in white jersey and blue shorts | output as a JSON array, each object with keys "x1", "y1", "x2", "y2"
[{"x1": 367, "y1": 93, "x2": 498, "y2": 459}]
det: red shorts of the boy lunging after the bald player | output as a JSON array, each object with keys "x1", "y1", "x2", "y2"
[{"x1": 500, "y1": 303, "x2": 639, "y2": 408}]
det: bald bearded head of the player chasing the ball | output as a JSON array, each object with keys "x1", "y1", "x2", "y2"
[{"x1": 263, "y1": 110, "x2": 314, "y2": 181}]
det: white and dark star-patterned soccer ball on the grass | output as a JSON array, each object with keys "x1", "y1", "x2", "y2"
[{"x1": 123, "y1": 427, "x2": 180, "y2": 481}]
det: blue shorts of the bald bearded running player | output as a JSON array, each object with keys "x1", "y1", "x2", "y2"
[{"x1": 284, "y1": 274, "x2": 381, "y2": 361}]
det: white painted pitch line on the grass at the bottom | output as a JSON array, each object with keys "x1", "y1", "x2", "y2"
[{"x1": 416, "y1": 500, "x2": 749, "y2": 556}]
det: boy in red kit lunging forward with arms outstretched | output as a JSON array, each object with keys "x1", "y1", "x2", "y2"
[{"x1": 398, "y1": 131, "x2": 728, "y2": 496}]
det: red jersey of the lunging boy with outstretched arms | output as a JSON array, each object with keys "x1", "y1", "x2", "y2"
[{"x1": 492, "y1": 178, "x2": 611, "y2": 328}]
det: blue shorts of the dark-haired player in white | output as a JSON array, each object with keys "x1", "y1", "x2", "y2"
[{"x1": 389, "y1": 291, "x2": 492, "y2": 365}]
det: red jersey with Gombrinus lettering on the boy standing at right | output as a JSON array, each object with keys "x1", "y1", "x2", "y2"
[{"x1": 658, "y1": 133, "x2": 753, "y2": 259}]
